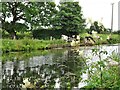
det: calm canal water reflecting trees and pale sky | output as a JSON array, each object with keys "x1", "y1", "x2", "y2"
[{"x1": 0, "y1": 45, "x2": 118, "y2": 90}]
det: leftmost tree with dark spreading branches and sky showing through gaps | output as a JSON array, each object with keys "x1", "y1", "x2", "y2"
[{"x1": 1, "y1": 2, "x2": 35, "y2": 39}]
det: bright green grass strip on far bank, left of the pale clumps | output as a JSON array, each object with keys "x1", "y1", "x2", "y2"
[{"x1": 0, "y1": 39, "x2": 67, "y2": 52}]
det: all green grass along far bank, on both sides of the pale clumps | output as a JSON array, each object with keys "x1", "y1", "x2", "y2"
[{"x1": 0, "y1": 34, "x2": 120, "y2": 53}]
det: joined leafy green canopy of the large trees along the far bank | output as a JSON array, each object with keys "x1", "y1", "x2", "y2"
[{"x1": 0, "y1": 2, "x2": 85, "y2": 38}]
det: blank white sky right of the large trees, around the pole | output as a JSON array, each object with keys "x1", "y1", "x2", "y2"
[{"x1": 55, "y1": 0, "x2": 120, "y2": 30}]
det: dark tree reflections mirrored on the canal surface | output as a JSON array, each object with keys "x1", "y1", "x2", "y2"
[{"x1": 2, "y1": 49, "x2": 84, "y2": 89}]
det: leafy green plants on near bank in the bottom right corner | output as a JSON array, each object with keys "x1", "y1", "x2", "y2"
[{"x1": 85, "y1": 48, "x2": 120, "y2": 88}]
